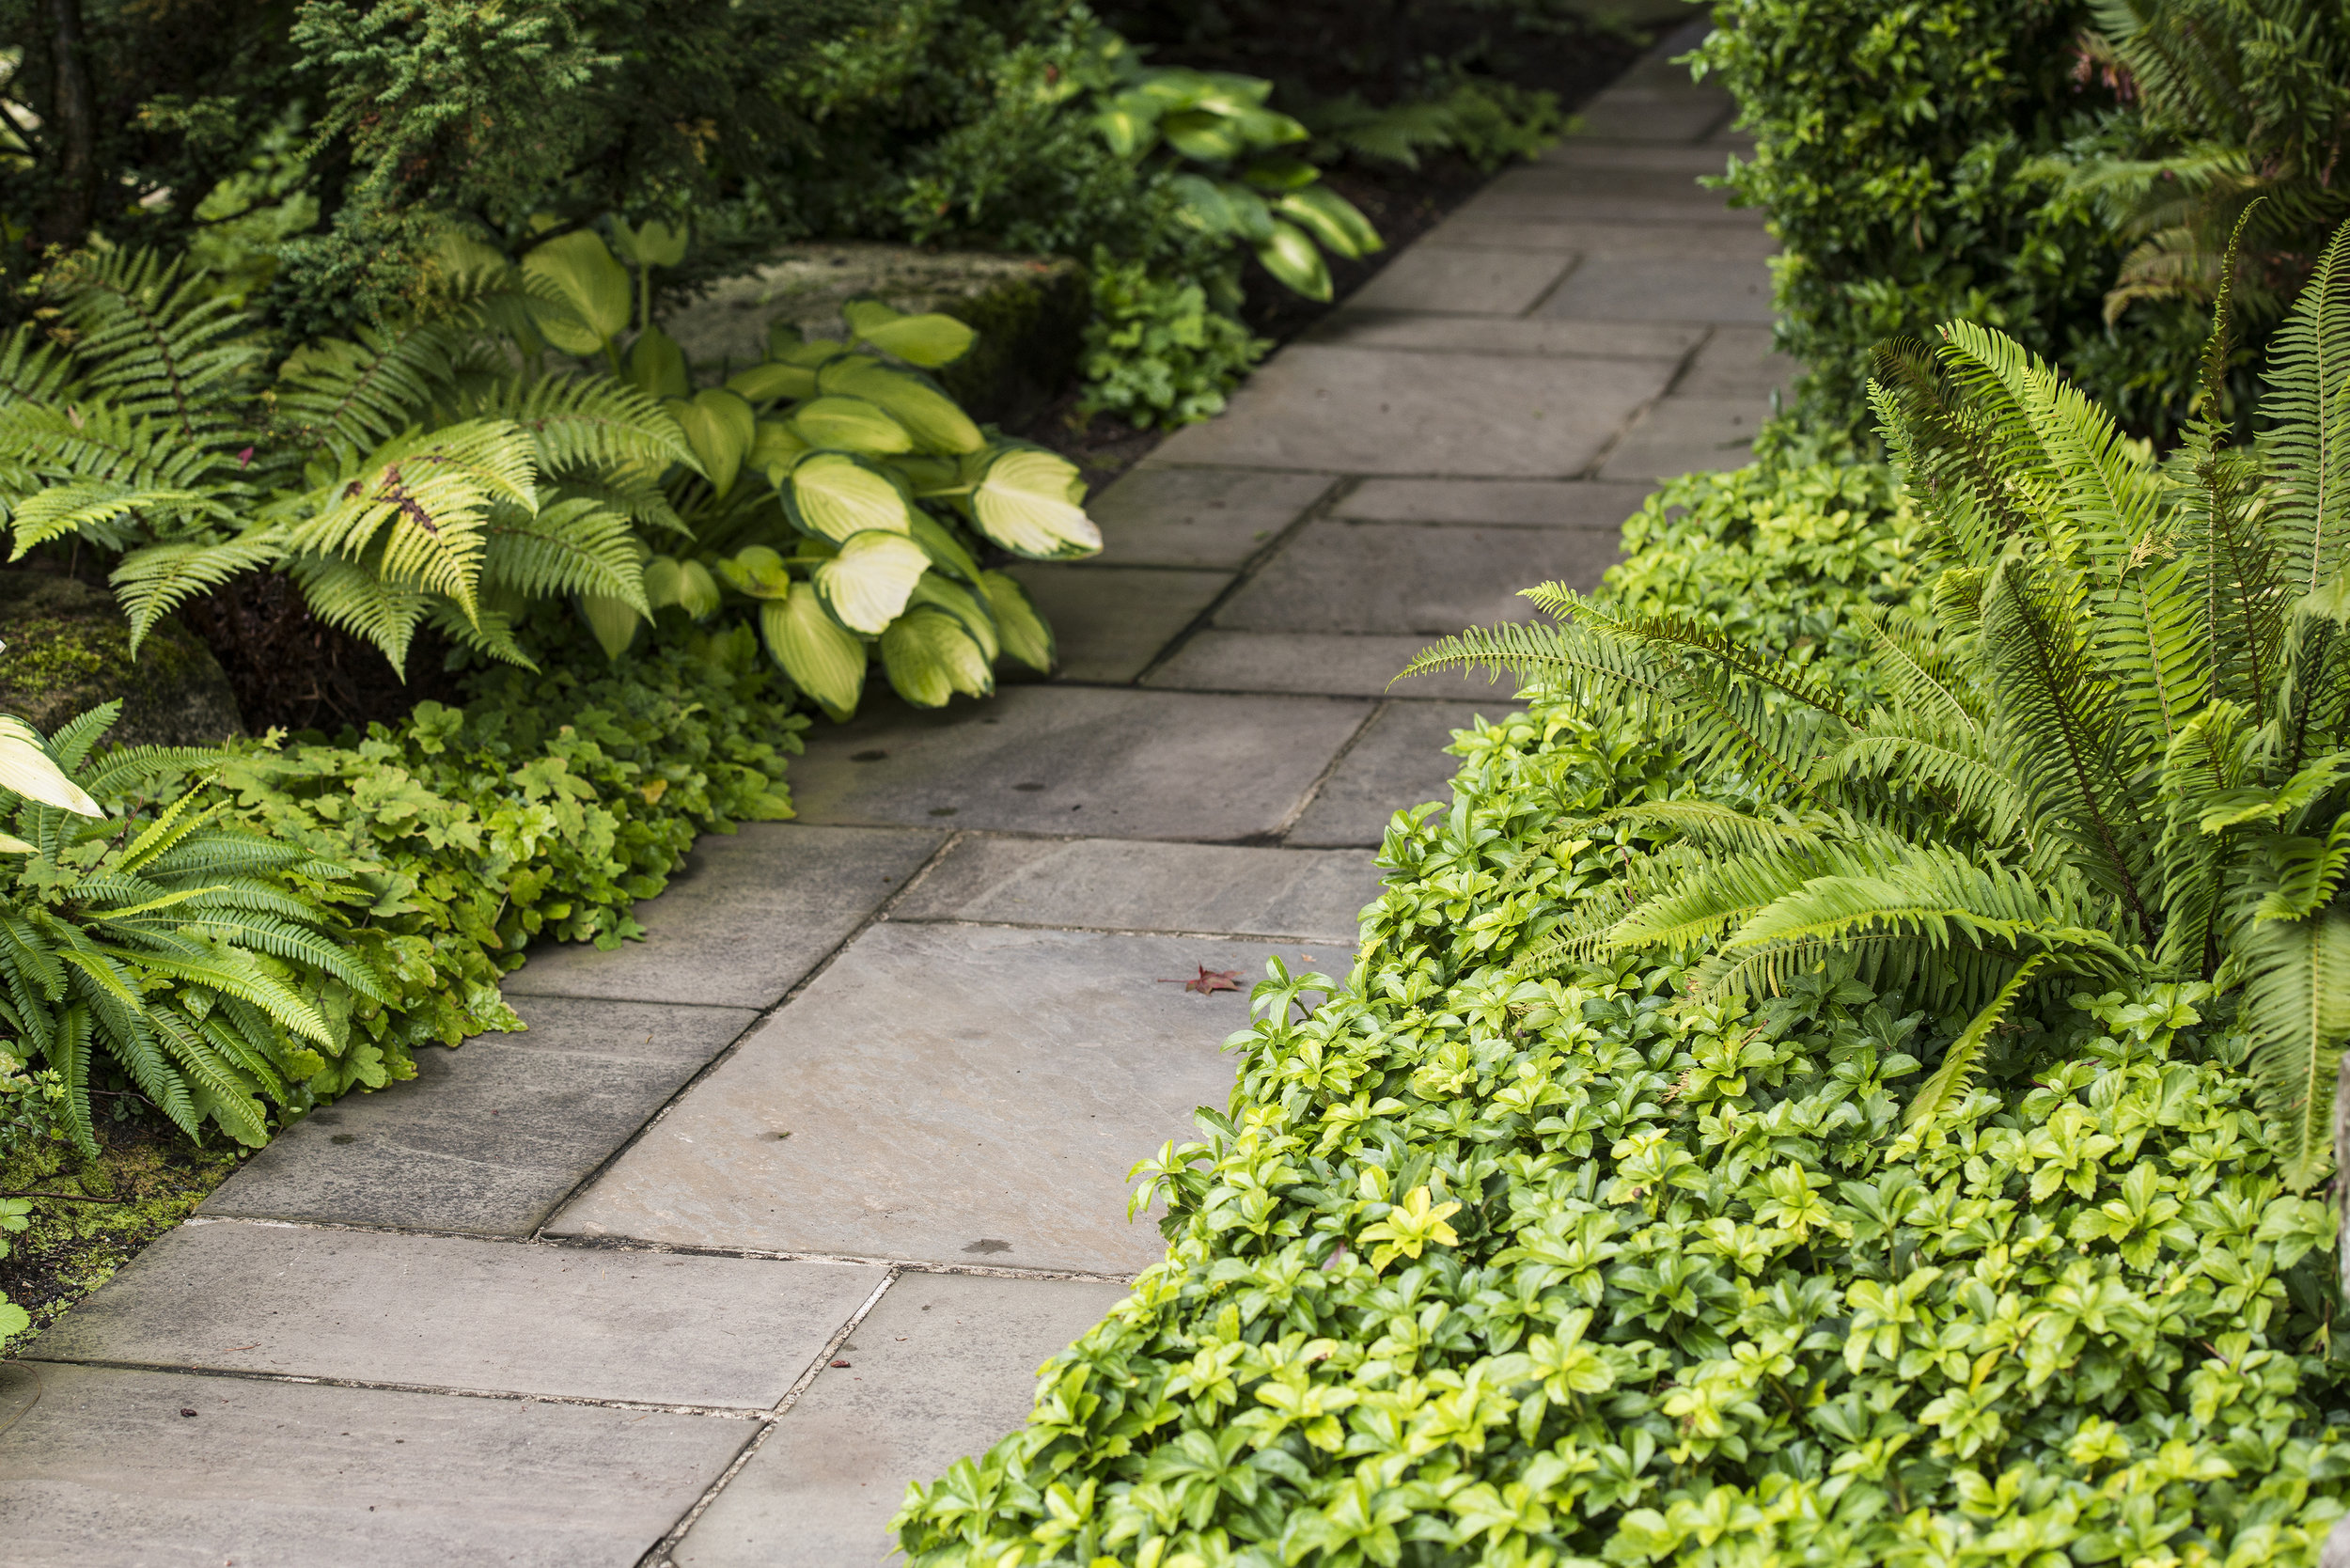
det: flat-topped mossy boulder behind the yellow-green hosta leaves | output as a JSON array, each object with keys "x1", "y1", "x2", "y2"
[{"x1": 663, "y1": 244, "x2": 1089, "y2": 423}]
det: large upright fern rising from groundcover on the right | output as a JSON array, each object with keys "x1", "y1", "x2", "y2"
[{"x1": 1415, "y1": 235, "x2": 2350, "y2": 1187}]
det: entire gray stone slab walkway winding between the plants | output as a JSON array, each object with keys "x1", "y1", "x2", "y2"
[{"x1": 0, "y1": 27, "x2": 1784, "y2": 1568}]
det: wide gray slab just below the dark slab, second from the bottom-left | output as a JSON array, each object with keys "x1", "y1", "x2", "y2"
[{"x1": 33, "y1": 1222, "x2": 879, "y2": 1410}]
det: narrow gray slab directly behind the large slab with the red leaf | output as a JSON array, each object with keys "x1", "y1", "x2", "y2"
[{"x1": 891, "y1": 835, "x2": 1380, "y2": 949}]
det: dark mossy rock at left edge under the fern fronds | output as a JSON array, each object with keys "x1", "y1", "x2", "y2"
[{"x1": 0, "y1": 572, "x2": 244, "y2": 745}]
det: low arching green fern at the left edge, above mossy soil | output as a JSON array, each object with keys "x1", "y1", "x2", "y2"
[{"x1": 0, "y1": 703, "x2": 388, "y2": 1154}]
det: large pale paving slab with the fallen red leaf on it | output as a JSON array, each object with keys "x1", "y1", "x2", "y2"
[{"x1": 553, "y1": 921, "x2": 1269, "y2": 1274}]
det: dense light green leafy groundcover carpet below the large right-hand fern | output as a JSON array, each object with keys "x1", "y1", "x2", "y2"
[{"x1": 898, "y1": 694, "x2": 2350, "y2": 1568}]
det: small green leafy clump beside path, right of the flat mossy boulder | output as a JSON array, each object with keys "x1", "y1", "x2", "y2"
[{"x1": 1079, "y1": 252, "x2": 1272, "y2": 431}]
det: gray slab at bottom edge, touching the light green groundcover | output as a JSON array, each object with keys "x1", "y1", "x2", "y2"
[{"x1": 675, "y1": 1274, "x2": 1126, "y2": 1568}]
